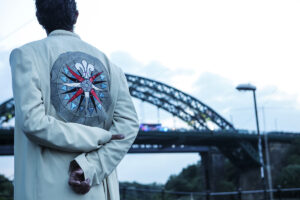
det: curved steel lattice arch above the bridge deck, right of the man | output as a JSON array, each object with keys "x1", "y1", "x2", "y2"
[{"x1": 126, "y1": 74, "x2": 234, "y2": 130}]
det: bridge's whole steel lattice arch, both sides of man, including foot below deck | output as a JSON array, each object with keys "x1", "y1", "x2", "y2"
[{"x1": 0, "y1": 74, "x2": 259, "y2": 168}]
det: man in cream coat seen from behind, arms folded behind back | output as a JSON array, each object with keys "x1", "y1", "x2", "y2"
[{"x1": 10, "y1": 0, "x2": 138, "y2": 200}]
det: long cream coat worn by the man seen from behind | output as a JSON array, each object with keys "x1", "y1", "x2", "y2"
[{"x1": 10, "y1": 30, "x2": 138, "y2": 200}]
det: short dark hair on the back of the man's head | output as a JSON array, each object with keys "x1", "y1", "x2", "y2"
[{"x1": 35, "y1": 0, "x2": 78, "y2": 34}]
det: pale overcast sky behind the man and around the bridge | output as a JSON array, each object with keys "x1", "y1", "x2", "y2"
[{"x1": 0, "y1": 0, "x2": 300, "y2": 183}]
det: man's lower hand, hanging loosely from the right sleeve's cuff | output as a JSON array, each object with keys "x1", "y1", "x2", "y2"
[{"x1": 69, "y1": 162, "x2": 91, "y2": 194}]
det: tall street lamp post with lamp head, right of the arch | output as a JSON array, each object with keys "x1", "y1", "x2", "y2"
[{"x1": 236, "y1": 84, "x2": 273, "y2": 199}]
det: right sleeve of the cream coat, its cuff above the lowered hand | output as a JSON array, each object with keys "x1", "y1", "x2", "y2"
[{"x1": 74, "y1": 67, "x2": 139, "y2": 186}]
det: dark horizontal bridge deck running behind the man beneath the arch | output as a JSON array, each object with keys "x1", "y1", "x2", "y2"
[{"x1": 0, "y1": 128, "x2": 300, "y2": 155}]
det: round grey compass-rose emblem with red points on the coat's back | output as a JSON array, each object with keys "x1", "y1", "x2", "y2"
[{"x1": 51, "y1": 52, "x2": 111, "y2": 126}]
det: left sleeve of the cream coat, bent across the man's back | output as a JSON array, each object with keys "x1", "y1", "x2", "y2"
[{"x1": 10, "y1": 48, "x2": 111, "y2": 153}]
